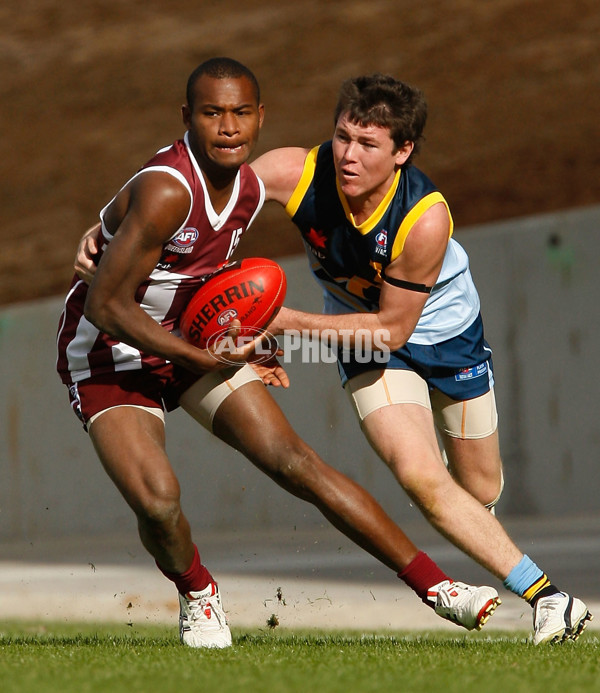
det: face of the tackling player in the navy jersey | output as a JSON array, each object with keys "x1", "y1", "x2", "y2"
[{"x1": 333, "y1": 113, "x2": 413, "y2": 213}]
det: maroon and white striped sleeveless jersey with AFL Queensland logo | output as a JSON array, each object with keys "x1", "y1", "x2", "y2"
[{"x1": 57, "y1": 133, "x2": 265, "y2": 385}]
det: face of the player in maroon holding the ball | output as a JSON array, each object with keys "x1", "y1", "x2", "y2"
[{"x1": 182, "y1": 75, "x2": 264, "y2": 173}]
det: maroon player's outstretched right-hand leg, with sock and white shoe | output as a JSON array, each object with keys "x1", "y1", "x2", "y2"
[{"x1": 207, "y1": 382, "x2": 500, "y2": 630}]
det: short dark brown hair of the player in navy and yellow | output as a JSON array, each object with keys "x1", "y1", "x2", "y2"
[{"x1": 334, "y1": 73, "x2": 427, "y2": 165}]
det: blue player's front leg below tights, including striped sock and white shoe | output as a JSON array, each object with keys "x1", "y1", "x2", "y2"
[{"x1": 362, "y1": 404, "x2": 592, "y2": 644}]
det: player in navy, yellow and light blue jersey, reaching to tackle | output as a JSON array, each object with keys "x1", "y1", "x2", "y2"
[{"x1": 252, "y1": 74, "x2": 591, "y2": 644}]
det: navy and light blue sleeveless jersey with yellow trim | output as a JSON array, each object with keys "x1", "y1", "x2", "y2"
[{"x1": 285, "y1": 141, "x2": 479, "y2": 344}]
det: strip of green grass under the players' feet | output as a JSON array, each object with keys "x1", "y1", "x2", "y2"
[{"x1": 0, "y1": 623, "x2": 600, "y2": 693}]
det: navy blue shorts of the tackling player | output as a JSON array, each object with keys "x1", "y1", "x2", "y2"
[{"x1": 338, "y1": 315, "x2": 494, "y2": 401}]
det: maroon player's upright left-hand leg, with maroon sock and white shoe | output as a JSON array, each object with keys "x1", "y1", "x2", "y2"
[{"x1": 90, "y1": 407, "x2": 232, "y2": 648}]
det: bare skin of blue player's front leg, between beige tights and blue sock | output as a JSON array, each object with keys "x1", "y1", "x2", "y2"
[{"x1": 362, "y1": 404, "x2": 523, "y2": 579}]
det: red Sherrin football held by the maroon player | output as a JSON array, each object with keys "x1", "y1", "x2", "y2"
[{"x1": 179, "y1": 257, "x2": 287, "y2": 349}]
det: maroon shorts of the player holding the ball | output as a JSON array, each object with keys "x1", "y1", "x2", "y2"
[{"x1": 69, "y1": 363, "x2": 201, "y2": 428}]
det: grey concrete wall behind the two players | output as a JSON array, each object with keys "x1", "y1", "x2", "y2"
[{"x1": 0, "y1": 207, "x2": 600, "y2": 539}]
